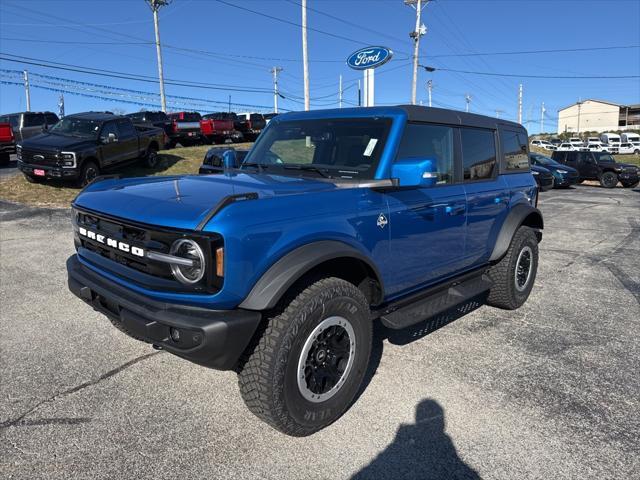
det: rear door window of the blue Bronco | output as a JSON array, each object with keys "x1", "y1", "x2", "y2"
[{"x1": 460, "y1": 128, "x2": 498, "y2": 182}]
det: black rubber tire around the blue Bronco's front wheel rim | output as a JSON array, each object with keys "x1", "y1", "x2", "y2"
[{"x1": 238, "y1": 277, "x2": 373, "y2": 437}]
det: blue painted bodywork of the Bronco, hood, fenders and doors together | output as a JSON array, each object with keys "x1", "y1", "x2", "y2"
[{"x1": 75, "y1": 107, "x2": 537, "y2": 309}]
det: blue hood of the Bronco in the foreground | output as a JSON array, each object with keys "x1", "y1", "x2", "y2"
[{"x1": 74, "y1": 173, "x2": 337, "y2": 230}]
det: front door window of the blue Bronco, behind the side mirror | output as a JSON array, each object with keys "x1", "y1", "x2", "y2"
[{"x1": 397, "y1": 123, "x2": 454, "y2": 184}]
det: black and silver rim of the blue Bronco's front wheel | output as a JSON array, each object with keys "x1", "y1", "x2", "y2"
[{"x1": 297, "y1": 317, "x2": 356, "y2": 402}]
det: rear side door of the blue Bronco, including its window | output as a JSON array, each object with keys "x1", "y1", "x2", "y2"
[{"x1": 460, "y1": 127, "x2": 510, "y2": 266}]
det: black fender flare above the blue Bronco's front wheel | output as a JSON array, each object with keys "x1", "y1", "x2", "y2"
[{"x1": 238, "y1": 240, "x2": 384, "y2": 310}]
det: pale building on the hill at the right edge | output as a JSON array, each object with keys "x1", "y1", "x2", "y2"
[{"x1": 558, "y1": 99, "x2": 640, "y2": 133}]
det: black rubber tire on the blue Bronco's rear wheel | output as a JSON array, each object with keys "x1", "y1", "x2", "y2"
[{"x1": 487, "y1": 226, "x2": 538, "y2": 310}]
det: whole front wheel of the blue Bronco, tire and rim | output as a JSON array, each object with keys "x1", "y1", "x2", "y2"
[{"x1": 238, "y1": 278, "x2": 372, "y2": 436}]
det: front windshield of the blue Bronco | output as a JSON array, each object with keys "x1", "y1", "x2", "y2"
[{"x1": 242, "y1": 118, "x2": 391, "y2": 178}]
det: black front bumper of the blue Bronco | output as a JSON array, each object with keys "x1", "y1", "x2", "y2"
[{"x1": 67, "y1": 255, "x2": 262, "y2": 370}]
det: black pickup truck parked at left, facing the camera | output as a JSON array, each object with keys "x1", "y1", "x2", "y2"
[{"x1": 16, "y1": 112, "x2": 165, "y2": 185}]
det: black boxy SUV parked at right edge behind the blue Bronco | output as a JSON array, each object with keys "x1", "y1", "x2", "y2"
[{"x1": 551, "y1": 151, "x2": 640, "y2": 188}]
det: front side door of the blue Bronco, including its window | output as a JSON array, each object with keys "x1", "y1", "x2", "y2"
[{"x1": 381, "y1": 123, "x2": 467, "y2": 295}]
